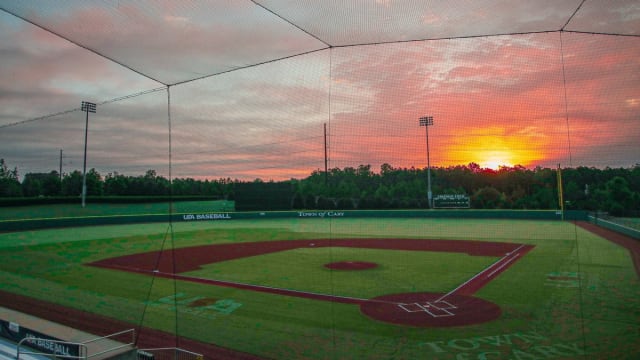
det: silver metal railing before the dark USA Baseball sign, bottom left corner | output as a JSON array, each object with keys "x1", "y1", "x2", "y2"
[{"x1": 16, "y1": 329, "x2": 135, "y2": 360}]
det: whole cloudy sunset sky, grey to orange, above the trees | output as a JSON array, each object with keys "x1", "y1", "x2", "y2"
[{"x1": 0, "y1": 0, "x2": 640, "y2": 180}]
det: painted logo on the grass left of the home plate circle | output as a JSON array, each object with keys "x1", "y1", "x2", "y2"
[{"x1": 147, "y1": 293, "x2": 242, "y2": 319}]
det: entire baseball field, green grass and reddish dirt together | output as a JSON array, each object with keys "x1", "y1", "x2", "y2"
[{"x1": 0, "y1": 207, "x2": 640, "y2": 359}]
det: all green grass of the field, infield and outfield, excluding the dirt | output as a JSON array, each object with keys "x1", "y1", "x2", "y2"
[{"x1": 0, "y1": 219, "x2": 640, "y2": 359}]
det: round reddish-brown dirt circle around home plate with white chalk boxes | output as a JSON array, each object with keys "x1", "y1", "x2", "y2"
[{"x1": 360, "y1": 293, "x2": 502, "y2": 327}]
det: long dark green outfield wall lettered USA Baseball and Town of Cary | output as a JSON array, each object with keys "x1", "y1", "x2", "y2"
[{"x1": 0, "y1": 210, "x2": 588, "y2": 232}]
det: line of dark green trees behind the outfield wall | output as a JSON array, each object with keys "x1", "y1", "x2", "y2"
[{"x1": 0, "y1": 159, "x2": 640, "y2": 216}]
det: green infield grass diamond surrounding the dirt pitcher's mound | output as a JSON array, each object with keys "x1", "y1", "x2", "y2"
[{"x1": 185, "y1": 246, "x2": 497, "y2": 299}]
